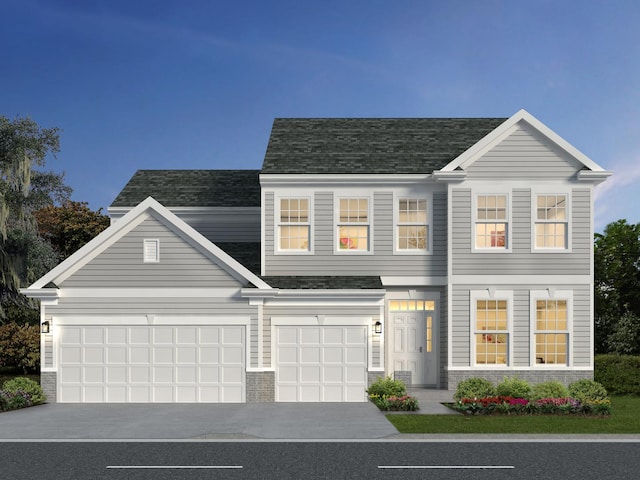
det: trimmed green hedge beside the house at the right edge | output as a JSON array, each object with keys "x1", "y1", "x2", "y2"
[{"x1": 593, "y1": 355, "x2": 640, "y2": 395}]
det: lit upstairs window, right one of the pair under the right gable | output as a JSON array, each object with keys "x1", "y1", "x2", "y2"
[{"x1": 535, "y1": 194, "x2": 569, "y2": 250}]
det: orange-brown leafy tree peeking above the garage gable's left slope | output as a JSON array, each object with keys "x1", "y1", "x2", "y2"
[{"x1": 34, "y1": 200, "x2": 110, "y2": 260}]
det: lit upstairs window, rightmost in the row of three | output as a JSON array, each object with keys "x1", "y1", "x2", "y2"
[{"x1": 396, "y1": 198, "x2": 429, "y2": 252}]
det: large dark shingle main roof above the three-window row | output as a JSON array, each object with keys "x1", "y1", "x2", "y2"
[{"x1": 262, "y1": 118, "x2": 507, "y2": 174}]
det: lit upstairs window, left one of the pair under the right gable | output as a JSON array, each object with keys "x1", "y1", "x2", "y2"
[{"x1": 475, "y1": 195, "x2": 509, "y2": 250}]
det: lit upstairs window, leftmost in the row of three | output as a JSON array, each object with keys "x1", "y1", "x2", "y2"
[{"x1": 278, "y1": 198, "x2": 311, "y2": 252}]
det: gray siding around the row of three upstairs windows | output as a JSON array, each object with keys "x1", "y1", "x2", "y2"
[{"x1": 264, "y1": 191, "x2": 447, "y2": 276}]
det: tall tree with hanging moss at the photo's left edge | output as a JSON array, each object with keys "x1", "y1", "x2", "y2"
[{"x1": 0, "y1": 115, "x2": 70, "y2": 314}]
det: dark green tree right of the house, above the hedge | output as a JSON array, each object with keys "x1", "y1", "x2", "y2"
[{"x1": 594, "y1": 220, "x2": 640, "y2": 353}]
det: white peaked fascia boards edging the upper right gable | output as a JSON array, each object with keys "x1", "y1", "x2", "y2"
[{"x1": 440, "y1": 109, "x2": 604, "y2": 172}]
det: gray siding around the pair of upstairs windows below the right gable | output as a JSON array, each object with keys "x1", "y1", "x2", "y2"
[{"x1": 451, "y1": 188, "x2": 592, "y2": 275}]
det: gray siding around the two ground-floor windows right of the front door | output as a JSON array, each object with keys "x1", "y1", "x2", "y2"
[{"x1": 451, "y1": 284, "x2": 592, "y2": 368}]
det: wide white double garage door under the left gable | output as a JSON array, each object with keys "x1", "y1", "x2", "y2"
[{"x1": 58, "y1": 326, "x2": 245, "y2": 403}]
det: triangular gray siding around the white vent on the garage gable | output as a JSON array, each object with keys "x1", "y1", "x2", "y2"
[{"x1": 60, "y1": 216, "x2": 245, "y2": 287}]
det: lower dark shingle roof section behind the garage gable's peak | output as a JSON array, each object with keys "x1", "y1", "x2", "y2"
[{"x1": 111, "y1": 170, "x2": 260, "y2": 207}]
